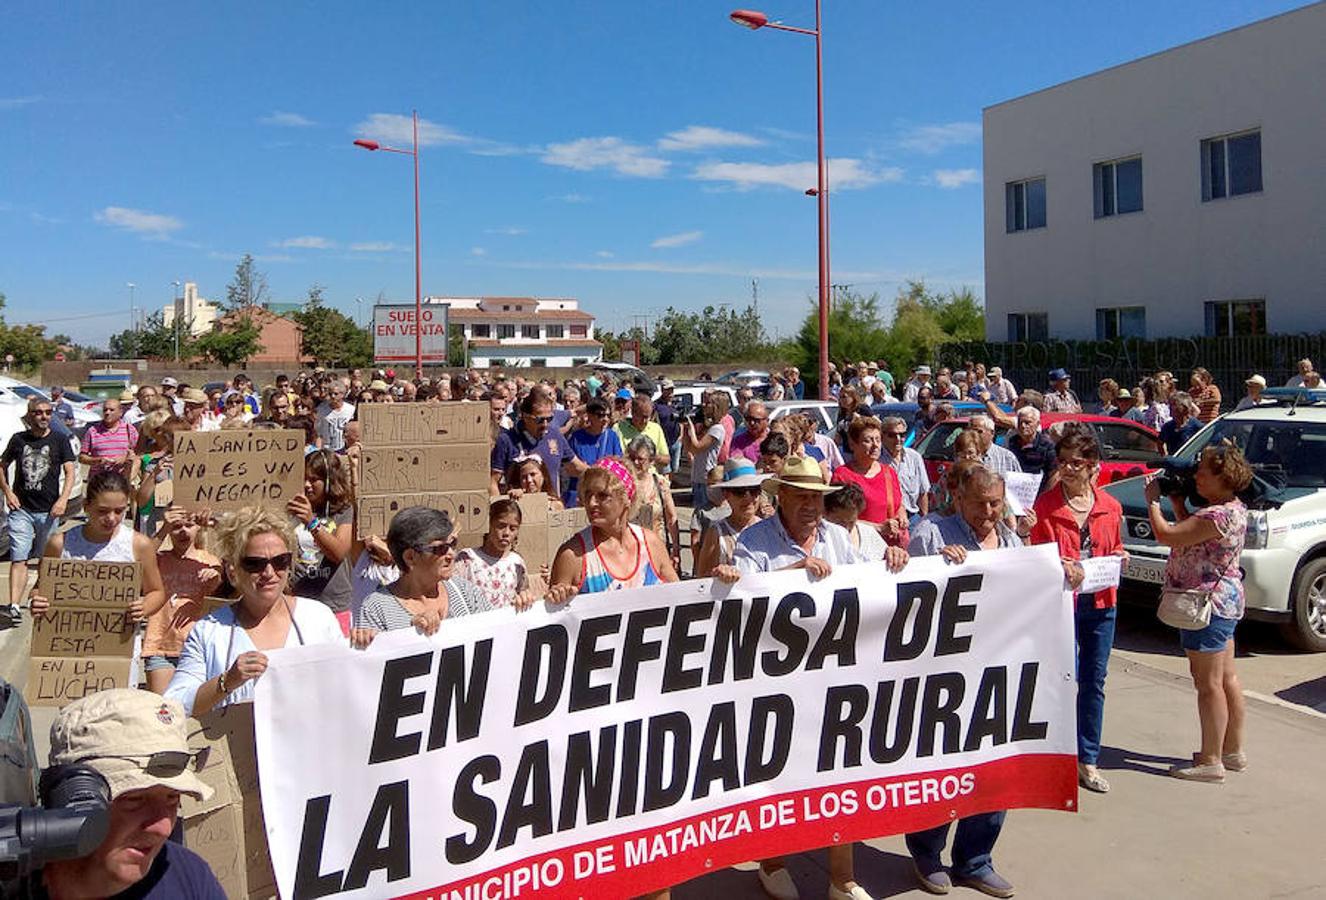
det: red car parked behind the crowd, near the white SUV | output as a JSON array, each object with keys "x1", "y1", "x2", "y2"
[{"x1": 915, "y1": 412, "x2": 1166, "y2": 493}]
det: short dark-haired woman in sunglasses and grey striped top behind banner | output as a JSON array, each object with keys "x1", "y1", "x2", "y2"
[{"x1": 350, "y1": 506, "x2": 495, "y2": 649}]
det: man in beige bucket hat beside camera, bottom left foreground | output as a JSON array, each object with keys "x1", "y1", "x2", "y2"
[{"x1": 28, "y1": 688, "x2": 225, "y2": 900}]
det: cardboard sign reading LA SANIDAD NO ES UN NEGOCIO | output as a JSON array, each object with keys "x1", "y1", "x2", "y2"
[{"x1": 174, "y1": 428, "x2": 304, "y2": 510}]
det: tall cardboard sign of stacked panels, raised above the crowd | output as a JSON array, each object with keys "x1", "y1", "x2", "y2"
[{"x1": 357, "y1": 403, "x2": 492, "y2": 545}]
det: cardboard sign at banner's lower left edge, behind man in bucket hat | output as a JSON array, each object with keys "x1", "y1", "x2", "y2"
[{"x1": 180, "y1": 704, "x2": 276, "y2": 900}]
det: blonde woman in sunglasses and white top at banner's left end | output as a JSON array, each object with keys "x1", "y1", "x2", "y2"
[{"x1": 165, "y1": 506, "x2": 345, "y2": 716}]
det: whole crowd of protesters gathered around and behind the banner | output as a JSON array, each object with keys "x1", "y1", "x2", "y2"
[{"x1": 0, "y1": 352, "x2": 1294, "y2": 900}]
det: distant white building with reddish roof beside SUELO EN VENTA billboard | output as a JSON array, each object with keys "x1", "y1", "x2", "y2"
[{"x1": 424, "y1": 297, "x2": 603, "y2": 367}]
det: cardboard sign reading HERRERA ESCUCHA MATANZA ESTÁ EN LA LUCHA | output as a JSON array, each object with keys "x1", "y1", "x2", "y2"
[{"x1": 24, "y1": 558, "x2": 142, "y2": 706}]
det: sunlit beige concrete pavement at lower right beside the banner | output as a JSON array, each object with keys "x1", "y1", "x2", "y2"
[{"x1": 672, "y1": 655, "x2": 1326, "y2": 900}]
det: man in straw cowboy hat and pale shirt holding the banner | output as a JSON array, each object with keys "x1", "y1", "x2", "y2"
[{"x1": 713, "y1": 456, "x2": 907, "y2": 900}]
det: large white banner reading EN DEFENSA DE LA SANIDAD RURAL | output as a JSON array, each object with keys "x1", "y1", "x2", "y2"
[{"x1": 256, "y1": 546, "x2": 1077, "y2": 900}]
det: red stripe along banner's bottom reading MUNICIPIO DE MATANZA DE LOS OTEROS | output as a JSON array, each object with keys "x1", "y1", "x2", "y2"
[{"x1": 389, "y1": 754, "x2": 1078, "y2": 900}]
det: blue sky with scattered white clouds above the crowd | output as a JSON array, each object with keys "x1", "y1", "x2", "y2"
[{"x1": 0, "y1": 0, "x2": 1302, "y2": 342}]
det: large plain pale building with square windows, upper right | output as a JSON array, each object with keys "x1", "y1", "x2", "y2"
[{"x1": 984, "y1": 3, "x2": 1326, "y2": 341}]
